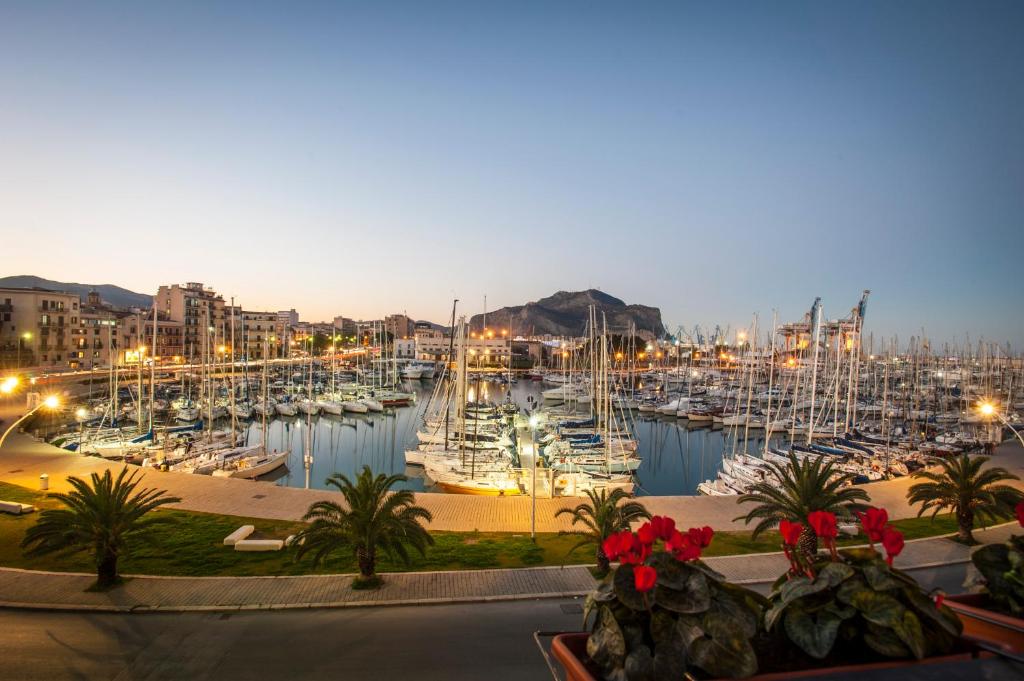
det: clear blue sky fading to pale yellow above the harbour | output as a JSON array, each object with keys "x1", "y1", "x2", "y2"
[{"x1": 0, "y1": 1, "x2": 1024, "y2": 350}]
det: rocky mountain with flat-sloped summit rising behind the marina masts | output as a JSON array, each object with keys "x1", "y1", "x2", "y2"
[{"x1": 469, "y1": 289, "x2": 665, "y2": 337}]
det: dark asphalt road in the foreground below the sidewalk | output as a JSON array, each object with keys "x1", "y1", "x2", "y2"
[{"x1": 0, "y1": 565, "x2": 999, "y2": 681}]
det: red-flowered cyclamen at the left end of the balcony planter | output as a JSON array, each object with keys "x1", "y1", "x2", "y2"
[{"x1": 552, "y1": 516, "x2": 765, "y2": 681}]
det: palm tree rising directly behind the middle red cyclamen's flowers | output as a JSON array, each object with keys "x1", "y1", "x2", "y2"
[{"x1": 736, "y1": 452, "x2": 867, "y2": 556}]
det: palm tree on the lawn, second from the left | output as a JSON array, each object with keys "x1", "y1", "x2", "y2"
[{"x1": 296, "y1": 466, "x2": 434, "y2": 582}]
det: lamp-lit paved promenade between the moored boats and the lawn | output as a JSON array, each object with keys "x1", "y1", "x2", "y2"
[{"x1": 0, "y1": 399, "x2": 1024, "y2": 531}]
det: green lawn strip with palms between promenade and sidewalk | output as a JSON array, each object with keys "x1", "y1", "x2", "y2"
[{"x1": 0, "y1": 482, "x2": 995, "y2": 577}]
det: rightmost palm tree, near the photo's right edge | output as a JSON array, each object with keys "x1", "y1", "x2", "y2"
[{"x1": 906, "y1": 454, "x2": 1024, "y2": 544}]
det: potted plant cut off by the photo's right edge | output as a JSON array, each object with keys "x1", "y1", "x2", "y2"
[{"x1": 946, "y1": 502, "x2": 1024, "y2": 654}]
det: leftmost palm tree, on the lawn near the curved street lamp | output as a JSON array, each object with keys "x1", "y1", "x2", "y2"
[{"x1": 22, "y1": 466, "x2": 181, "y2": 589}]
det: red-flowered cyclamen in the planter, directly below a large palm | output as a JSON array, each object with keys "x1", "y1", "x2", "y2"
[{"x1": 761, "y1": 508, "x2": 970, "y2": 676}]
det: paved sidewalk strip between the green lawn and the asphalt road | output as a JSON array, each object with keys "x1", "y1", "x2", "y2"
[{"x1": 0, "y1": 522, "x2": 1007, "y2": 612}]
